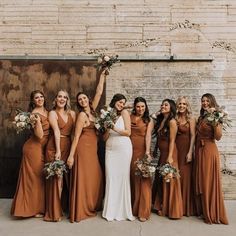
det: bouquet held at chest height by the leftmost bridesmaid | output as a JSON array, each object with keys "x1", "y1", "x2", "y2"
[{"x1": 13, "y1": 109, "x2": 36, "y2": 134}]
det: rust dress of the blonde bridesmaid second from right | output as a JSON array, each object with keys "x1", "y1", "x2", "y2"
[{"x1": 176, "y1": 122, "x2": 194, "y2": 216}]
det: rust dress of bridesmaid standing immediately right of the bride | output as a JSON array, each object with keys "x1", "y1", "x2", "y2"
[{"x1": 130, "y1": 115, "x2": 152, "y2": 219}]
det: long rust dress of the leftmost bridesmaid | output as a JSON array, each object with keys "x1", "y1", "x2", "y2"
[{"x1": 11, "y1": 114, "x2": 49, "y2": 217}]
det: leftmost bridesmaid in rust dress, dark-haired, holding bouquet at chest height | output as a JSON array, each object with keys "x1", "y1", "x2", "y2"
[{"x1": 11, "y1": 90, "x2": 49, "y2": 217}]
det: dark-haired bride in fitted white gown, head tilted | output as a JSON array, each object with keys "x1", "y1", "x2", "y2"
[{"x1": 102, "y1": 94, "x2": 134, "y2": 221}]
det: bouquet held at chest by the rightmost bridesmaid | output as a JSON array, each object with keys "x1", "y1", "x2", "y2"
[{"x1": 205, "y1": 107, "x2": 231, "y2": 130}]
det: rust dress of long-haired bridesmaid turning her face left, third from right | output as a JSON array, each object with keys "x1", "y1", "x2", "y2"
[{"x1": 153, "y1": 128, "x2": 183, "y2": 219}]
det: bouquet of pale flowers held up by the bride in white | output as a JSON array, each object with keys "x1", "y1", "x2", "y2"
[{"x1": 95, "y1": 107, "x2": 117, "y2": 133}]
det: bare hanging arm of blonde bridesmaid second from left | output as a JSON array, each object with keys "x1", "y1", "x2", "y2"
[{"x1": 48, "y1": 111, "x2": 61, "y2": 160}]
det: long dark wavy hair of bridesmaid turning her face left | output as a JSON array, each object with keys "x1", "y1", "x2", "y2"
[{"x1": 154, "y1": 98, "x2": 177, "y2": 135}]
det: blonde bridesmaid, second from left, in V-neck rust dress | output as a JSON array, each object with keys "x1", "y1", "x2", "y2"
[{"x1": 44, "y1": 90, "x2": 75, "y2": 221}]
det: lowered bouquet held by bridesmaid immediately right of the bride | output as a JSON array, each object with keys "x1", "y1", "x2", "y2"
[{"x1": 135, "y1": 155, "x2": 157, "y2": 178}]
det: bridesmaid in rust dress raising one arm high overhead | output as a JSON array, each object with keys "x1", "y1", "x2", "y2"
[{"x1": 67, "y1": 70, "x2": 106, "y2": 223}]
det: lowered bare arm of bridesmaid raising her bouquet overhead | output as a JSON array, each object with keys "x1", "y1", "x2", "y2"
[{"x1": 67, "y1": 112, "x2": 87, "y2": 169}]
